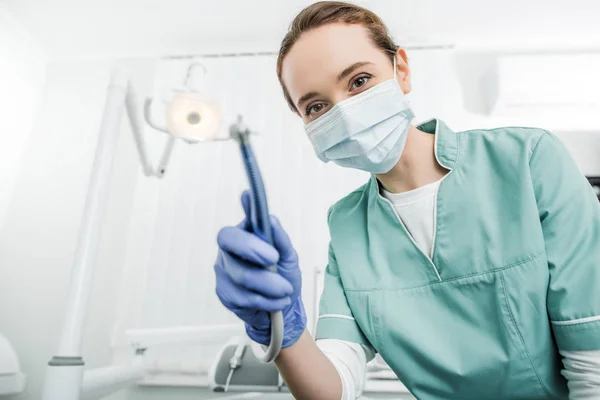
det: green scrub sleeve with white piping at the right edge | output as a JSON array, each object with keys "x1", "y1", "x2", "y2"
[{"x1": 530, "y1": 132, "x2": 600, "y2": 351}]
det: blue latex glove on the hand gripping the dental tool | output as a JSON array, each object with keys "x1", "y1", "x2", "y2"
[{"x1": 215, "y1": 191, "x2": 306, "y2": 348}]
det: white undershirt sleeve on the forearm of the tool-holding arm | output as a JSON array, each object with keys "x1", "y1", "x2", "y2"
[{"x1": 317, "y1": 339, "x2": 374, "y2": 400}]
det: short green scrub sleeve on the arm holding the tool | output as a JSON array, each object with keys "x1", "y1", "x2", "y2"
[{"x1": 315, "y1": 244, "x2": 371, "y2": 347}]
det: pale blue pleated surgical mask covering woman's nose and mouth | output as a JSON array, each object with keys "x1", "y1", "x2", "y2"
[{"x1": 304, "y1": 59, "x2": 414, "y2": 174}]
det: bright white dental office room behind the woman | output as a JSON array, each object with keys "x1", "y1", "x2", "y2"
[{"x1": 0, "y1": 0, "x2": 600, "y2": 400}]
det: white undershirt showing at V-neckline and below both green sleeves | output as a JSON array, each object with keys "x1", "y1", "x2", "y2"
[{"x1": 317, "y1": 180, "x2": 600, "y2": 400}]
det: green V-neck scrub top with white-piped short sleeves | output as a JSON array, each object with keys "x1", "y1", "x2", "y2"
[{"x1": 316, "y1": 120, "x2": 600, "y2": 400}]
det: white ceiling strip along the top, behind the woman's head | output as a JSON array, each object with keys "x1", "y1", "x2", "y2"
[{"x1": 0, "y1": 0, "x2": 600, "y2": 59}]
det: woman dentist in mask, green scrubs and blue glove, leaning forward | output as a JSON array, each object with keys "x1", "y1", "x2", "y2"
[{"x1": 215, "y1": 1, "x2": 600, "y2": 400}]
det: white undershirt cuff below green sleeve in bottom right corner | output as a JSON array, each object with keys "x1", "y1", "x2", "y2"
[{"x1": 560, "y1": 350, "x2": 600, "y2": 400}]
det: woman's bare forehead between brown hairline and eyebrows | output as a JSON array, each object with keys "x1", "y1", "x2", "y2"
[{"x1": 281, "y1": 23, "x2": 386, "y2": 102}]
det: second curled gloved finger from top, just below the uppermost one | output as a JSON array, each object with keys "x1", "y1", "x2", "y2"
[{"x1": 222, "y1": 252, "x2": 294, "y2": 298}]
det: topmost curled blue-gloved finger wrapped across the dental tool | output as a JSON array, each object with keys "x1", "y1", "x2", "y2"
[{"x1": 217, "y1": 227, "x2": 279, "y2": 267}]
